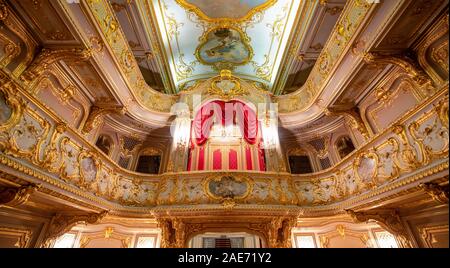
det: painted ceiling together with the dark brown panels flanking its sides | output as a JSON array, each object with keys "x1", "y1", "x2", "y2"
[{"x1": 111, "y1": 0, "x2": 345, "y2": 94}]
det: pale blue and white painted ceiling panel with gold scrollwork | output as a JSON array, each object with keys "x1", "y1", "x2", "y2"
[{"x1": 137, "y1": 0, "x2": 301, "y2": 91}]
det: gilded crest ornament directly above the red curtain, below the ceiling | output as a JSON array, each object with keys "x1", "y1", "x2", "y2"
[{"x1": 208, "y1": 70, "x2": 248, "y2": 100}]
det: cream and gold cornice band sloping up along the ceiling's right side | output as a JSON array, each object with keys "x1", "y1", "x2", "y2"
[{"x1": 275, "y1": 1, "x2": 406, "y2": 128}]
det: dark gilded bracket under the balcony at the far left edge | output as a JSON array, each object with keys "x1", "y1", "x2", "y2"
[{"x1": 0, "y1": 184, "x2": 41, "y2": 207}]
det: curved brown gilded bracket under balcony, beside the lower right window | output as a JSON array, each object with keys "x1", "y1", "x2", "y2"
[{"x1": 346, "y1": 210, "x2": 412, "y2": 248}]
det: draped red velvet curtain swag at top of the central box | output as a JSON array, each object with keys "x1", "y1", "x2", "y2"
[{"x1": 193, "y1": 100, "x2": 258, "y2": 146}]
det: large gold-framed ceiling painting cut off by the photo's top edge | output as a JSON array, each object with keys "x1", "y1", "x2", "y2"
[{"x1": 175, "y1": 0, "x2": 277, "y2": 23}]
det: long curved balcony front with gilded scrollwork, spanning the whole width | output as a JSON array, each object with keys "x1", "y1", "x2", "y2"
[{"x1": 0, "y1": 68, "x2": 448, "y2": 210}]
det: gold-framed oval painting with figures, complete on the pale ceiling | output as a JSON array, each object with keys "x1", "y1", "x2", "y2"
[{"x1": 195, "y1": 26, "x2": 253, "y2": 69}]
